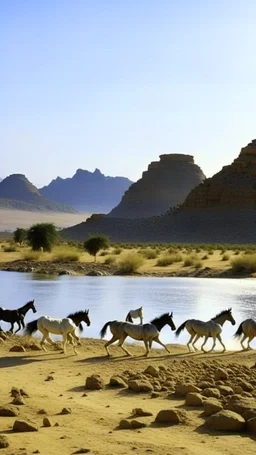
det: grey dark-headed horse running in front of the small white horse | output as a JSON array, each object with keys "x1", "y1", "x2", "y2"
[{"x1": 100, "y1": 313, "x2": 176, "y2": 357}]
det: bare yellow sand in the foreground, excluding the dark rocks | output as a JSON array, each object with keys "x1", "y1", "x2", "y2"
[{"x1": 0, "y1": 337, "x2": 256, "y2": 455}]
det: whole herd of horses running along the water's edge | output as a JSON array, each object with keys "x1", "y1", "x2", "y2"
[{"x1": 0, "y1": 300, "x2": 256, "y2": 356}]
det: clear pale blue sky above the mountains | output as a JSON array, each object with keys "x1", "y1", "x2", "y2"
[{"x1": 0, "y1": 0, "x2": 256, "y2": 186}]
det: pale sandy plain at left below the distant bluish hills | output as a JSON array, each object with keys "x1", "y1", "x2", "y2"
[{"x1": 0, "y1": 209, "x2": 90, "y2": 231}]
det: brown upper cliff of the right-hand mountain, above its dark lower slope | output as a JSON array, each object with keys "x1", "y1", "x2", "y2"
[{"x1": 182, "y1": 140, "x2": 256, "y2": 210}]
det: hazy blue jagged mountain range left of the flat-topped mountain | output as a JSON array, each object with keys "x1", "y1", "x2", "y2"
[{"x1": 39, "y1": 169, "x2": 133, "y2": 213}]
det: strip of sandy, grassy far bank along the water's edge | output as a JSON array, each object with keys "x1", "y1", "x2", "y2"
[{"x1": 0, "y1": 260, "x2": 252, "y2": 278}]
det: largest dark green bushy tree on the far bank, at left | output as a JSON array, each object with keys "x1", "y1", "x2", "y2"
[{"x1": 27, "y1": 223, "x2": 58, "y2": 252}]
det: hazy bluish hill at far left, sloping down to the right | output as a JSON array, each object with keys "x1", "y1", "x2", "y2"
[{"x1": 0, "y1": 174, "x2": 75, "y2": 213}]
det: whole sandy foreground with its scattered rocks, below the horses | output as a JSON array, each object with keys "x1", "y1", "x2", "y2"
[{"x1": 0, "y1": 335, "x2": 256, "y2": 455}]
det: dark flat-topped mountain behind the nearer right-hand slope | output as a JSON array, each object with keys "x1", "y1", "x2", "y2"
[{"x1": 108, "y1": 154, "x2": 205, "y2": 218}]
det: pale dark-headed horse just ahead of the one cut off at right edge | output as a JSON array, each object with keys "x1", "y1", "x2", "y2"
[{"x1": 175, "y1": 308, "x2": 236, "y2": 352}]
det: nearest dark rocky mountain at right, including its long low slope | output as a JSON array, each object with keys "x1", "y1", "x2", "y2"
[{"x1": 63, "y1": 140, "x2": 256, "y2": 243}]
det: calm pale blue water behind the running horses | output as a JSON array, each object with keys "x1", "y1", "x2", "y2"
[{"x1": 0, "y1": 272, "x2": 256, "y2": 349}]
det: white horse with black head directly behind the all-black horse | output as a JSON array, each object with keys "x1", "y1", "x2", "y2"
[{"x1": 25, "y1": 310, "x2": 91, "y2": 354}]
